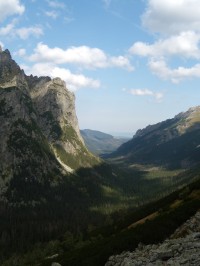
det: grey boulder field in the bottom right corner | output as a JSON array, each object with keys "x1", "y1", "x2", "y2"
[{"x1": 105, "y1": 211, "x2": 200, "y2": 266}]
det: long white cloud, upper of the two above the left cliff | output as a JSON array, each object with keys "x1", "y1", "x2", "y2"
[{"x1": 30, "y1": 43, "x2": 133, "y2": 70}]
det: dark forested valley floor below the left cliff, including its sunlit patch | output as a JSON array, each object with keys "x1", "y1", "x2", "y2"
[{"x1": 0, "y1": 156, "x2": 199, "y2": 256}]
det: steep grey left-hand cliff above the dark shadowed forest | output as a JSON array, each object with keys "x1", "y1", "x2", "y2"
[{"x1": 0, "y1": 47, "x2": 98, "y2": 197}]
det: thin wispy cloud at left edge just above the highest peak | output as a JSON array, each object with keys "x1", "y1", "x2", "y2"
[{"x1": 0, "y1": 19, "x2": 43, "y2": 40}]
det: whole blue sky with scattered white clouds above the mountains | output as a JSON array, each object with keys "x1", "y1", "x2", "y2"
[{"x1": 0, "y1": 0, "x2": 200, "y2": 135}]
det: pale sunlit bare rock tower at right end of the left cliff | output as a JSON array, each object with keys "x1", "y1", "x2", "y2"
[{"x1": 31, "y1": 78, "x2": 82, "y2": 144}]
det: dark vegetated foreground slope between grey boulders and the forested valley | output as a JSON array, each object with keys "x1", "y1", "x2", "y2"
[{"x1": 2, "y1": 168, "x2": 200, "y2": 266}]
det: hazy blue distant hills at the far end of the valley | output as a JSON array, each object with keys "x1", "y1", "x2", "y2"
[{"x1": 80, "y1": 129, "x2": 129, "y2": 155}]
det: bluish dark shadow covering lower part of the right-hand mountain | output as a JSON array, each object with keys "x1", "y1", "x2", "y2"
[{"x1": 108, "y1": 123, "x2": 200, "y2": 169}]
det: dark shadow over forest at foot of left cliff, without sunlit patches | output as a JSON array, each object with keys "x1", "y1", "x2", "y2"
[{"x1": 0, "y1": 163, "x2": 142, "y2": 255}]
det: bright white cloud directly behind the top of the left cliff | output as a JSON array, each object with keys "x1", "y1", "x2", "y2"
[{"x1": 21, "y1": 63, "x2": 100, "y2": 91}]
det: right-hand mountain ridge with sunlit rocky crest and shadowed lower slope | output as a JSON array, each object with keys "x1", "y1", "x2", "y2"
[{"x1": 111, "y1": 106, "x2": 200, "y2": 168}]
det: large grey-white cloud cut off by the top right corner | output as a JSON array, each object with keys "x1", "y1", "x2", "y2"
[{"x1": 142, "y1": 0, "x2": 200, "y2": 34}]
